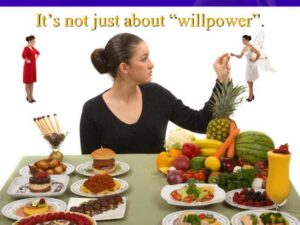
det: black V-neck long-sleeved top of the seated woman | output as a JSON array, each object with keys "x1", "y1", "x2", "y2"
[{"x1": 80, "y1": 81, "x2": 220, "y2": 154}]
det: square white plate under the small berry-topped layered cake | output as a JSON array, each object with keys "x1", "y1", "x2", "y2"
[{"x1": 7, "y1": 175, "x2": 69, "y2": 198}]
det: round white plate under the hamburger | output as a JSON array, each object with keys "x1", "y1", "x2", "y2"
[{"x1": 76, "y1": 161, "x2": 130, "y2": 177}]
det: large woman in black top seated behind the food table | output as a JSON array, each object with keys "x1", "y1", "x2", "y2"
[{"x1": 80, "y1": 33, "x2": 230, "y2": 154}]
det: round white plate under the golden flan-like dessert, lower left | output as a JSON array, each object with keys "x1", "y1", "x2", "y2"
[{"x1": 1, "y1": 198, "x2": 67, "y2": 220}]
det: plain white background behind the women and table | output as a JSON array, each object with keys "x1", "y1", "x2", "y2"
[{"x1": 0, "y1": 8, "x2": 300, "y2": 193}]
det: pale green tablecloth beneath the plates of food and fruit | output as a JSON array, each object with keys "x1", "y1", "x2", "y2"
[{"x1": 0, "y1": 154, "x2": 300, "y2": 225}]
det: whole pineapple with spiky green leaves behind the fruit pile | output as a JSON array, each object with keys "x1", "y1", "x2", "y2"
[{"x1": 206, "y1": 80, "x2": 246, "y2": 142}]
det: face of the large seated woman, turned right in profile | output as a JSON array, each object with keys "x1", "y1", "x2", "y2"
[{"x1": 127, "y1": 41, "x2": 154, "y2": 84}]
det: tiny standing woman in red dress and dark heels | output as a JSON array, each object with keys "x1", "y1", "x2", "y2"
[{"x1": 22, "y1": 35, "x2": 40, "y2": 103}]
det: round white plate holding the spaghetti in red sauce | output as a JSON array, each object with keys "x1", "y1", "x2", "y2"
[{"x1": 70, "y1": 178, "x2": 129, "y2": 198}]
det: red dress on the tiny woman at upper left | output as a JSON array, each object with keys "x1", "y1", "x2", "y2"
[{"x1": 22, "y1": 46, "x2": 40, "y2": 84}]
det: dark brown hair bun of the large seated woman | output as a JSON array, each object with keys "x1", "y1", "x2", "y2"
[{"x1": 91, "y1": 48, "x2": 109, "y2": 74}]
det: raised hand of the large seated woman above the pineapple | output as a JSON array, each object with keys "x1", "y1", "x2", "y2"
[{"x1": 214, "y1": 53, "x2": 230, "y2": 82}]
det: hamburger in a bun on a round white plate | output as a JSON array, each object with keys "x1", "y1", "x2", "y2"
[{"x1": 91, "y1": 148, "x2": 116, "y2": 174}]
